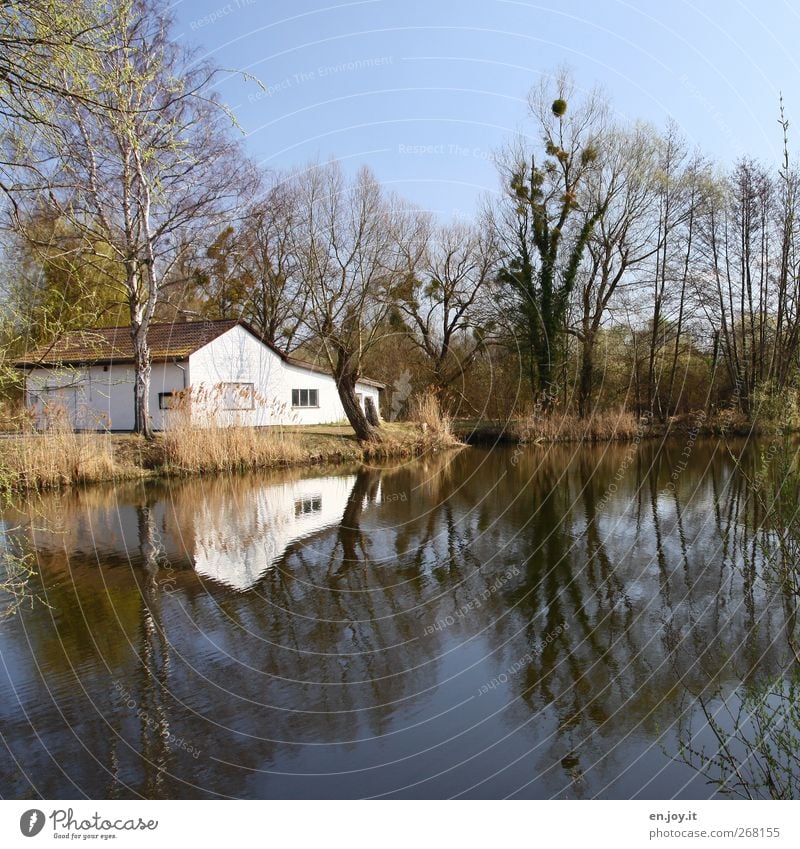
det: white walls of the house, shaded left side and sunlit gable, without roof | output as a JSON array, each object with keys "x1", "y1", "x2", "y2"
[{"x1": 26, "y1": 327, "x2": 380, "y2": 431}]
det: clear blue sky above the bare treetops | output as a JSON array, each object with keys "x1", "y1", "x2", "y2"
[{"x1": 173, "y1": 0, "x2": 800, "y2": 218}]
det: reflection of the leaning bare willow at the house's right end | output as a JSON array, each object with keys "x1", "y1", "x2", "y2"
[{"x1": 240, "y1": 460, "x2": 444, "y2": 744}]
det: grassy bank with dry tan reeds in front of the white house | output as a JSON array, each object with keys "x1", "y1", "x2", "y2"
[{"x1": 0, "y1": 422, "x2": 459, "y2": 492}]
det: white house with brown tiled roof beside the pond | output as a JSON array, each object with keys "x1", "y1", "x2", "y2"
[{"x1": 17, "y1": 319, "x2": 383, "y2": 431}]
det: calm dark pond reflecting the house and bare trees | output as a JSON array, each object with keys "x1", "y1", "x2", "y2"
[{"x1": 0, "y1": 439, "x2": 788, "y2": 799}]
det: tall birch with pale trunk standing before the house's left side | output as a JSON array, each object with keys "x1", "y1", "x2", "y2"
[{"x1": 15, "y1": 0, "x2": 252, "y2": 437}]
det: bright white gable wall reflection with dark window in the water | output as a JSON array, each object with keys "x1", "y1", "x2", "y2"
[{"x1": 193, "y1": 475, "x2": 364, "y2": 590}]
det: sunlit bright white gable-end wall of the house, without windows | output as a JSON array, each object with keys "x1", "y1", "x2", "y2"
[{"x1": 189, "y1": 327, "x2": 378, "y2": 426}]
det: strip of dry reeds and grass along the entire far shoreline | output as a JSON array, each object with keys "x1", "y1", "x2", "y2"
[{"x1": 0, "y1": 414, "x2": 781, "y2": 497}]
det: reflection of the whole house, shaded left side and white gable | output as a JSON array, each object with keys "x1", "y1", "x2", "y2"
[{"x1": 22, "y1": 475, "x2": 382, "y2": 592}]
